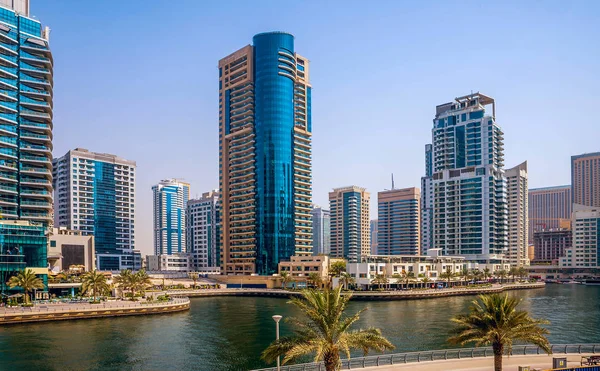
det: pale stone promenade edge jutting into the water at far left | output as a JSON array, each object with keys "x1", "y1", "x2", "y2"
[{"x1": 0, "y1": 298, "x2": 190, "y2": 325}]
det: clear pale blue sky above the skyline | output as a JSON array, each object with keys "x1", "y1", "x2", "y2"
[{"x1": 31, "y1": 0, "x2": 600, "y2": 253}]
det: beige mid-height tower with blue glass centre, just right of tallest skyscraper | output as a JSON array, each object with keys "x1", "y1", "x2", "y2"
[{"x1": 329, "y1": 186, "x2": 371, "y2": 262}]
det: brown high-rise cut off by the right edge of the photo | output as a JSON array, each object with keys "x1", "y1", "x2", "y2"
[{"x1": 571, "y1": 152, "x2": 600, "y2": 207}]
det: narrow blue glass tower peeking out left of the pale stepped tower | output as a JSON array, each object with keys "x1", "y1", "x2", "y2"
[{"x1": 421, "y1": 144, "x2": 433, "y2": 255}]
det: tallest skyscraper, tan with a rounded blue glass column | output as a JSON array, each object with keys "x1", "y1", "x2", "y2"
[{"x1": 219, "y1": 32, "x2": 312, "y2": 274}]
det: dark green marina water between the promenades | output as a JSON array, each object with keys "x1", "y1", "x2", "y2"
[{"x1": 0, "y1": 285, "x2": 600, "y2": 371}]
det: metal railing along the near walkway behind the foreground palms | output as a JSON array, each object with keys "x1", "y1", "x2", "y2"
[{"x1": 254, "y1": 344, "x2": 600, "y2": 371}]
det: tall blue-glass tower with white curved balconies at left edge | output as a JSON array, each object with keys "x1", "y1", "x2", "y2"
[{"x1": 0, "y1": 0, "x2": 54, "y2": 293}]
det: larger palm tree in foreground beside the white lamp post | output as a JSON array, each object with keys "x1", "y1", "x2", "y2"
[{"x1": 262, "y1": 286, "x2": 394, "y2": 371}]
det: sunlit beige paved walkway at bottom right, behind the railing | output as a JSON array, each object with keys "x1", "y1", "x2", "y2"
[{"x1": 361, "y1": 354, "x2": 586, "y2": 371}]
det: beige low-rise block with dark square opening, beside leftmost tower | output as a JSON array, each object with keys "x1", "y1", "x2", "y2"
[{"x1": 48, "y1": 227, "x2": 96, "y2": 273}]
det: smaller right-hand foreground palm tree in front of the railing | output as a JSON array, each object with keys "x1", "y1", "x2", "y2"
[{"x1": 448, "y1": 294, "x2": 551, "y2": 371}]
